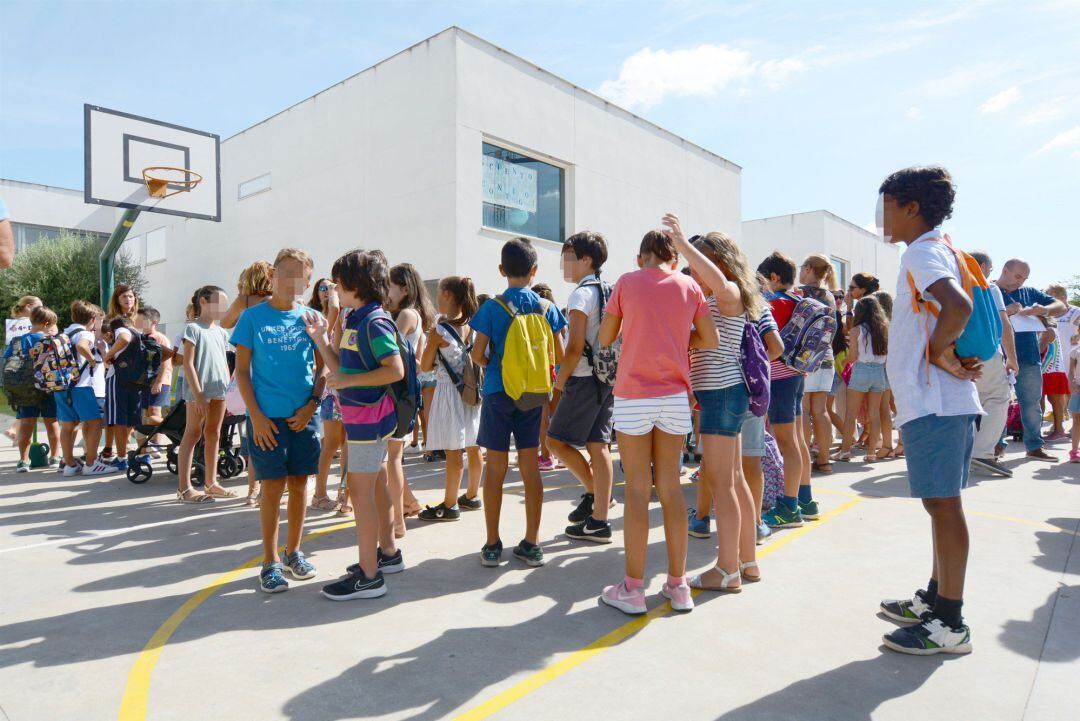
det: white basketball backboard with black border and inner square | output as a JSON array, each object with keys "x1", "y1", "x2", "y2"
[{"x1": 83, "y1": 105, "x2": 221, "y2": 221}]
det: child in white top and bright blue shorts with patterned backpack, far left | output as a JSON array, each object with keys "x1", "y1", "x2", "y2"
[{"x1": 52, "y1": 300, "x2": 116, "y2": 478}]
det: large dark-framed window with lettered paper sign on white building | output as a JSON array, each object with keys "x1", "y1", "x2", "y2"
[{"x1": 483, "y1": 142, "x2": 565, "y2": 243}]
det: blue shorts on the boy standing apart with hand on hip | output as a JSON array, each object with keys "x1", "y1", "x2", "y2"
[{"x1": 900, "y1": 416, "x2": 975, "y2": 499}]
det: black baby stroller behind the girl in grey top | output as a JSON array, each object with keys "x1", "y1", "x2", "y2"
[{"x1": 127, "y1": 400, "x2": 247, "y2": 488}]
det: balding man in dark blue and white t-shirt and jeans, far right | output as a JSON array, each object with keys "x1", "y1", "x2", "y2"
[{"x1": 997, "y1": 258, "x2": 1066, "y2": 462}]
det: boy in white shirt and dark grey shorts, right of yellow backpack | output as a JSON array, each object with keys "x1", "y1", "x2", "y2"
[{"x1": 548, "y1": 231, "x2": 615, "y2": 543}]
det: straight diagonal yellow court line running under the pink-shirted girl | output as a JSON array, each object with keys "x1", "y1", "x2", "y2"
[{"x1": 444, "y1": 498, "x2": 864, "y2": 721}]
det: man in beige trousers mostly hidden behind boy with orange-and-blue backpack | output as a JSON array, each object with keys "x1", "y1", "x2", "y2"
[{"x1": 971, "y1": 250, "x2": 1020, "y2": 478}]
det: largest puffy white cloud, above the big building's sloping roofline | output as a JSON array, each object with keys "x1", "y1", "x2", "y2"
[{"x1": 598, "y1": 44, "x2": 768, "y2": 108}]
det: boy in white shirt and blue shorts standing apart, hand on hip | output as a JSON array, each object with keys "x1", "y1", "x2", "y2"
[{"x1": 878, "y1": 167, "x2": 983, "y2": 655}]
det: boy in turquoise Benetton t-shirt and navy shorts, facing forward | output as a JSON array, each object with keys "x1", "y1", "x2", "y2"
[{"x1": 232, "y1": 248, "x2": 325, "y2": 594}]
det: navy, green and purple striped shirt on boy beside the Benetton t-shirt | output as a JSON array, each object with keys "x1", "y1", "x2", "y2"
[{"x1": 338, "y1": 303, "x2": 399, "y2": 444}]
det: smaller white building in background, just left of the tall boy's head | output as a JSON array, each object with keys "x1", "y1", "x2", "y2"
[{"x1": 742, "y1": 210, "x2": 900, "y2": 293}]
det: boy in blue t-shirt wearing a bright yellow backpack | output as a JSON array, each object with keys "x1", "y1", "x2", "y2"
[{"x1": 472, "y1": 237, "x2": 566, "y2": 567}]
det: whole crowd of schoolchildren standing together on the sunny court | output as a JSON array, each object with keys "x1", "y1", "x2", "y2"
[{"x1": 10, "y1": 167, "x2": 1080, "y2": 654}]
